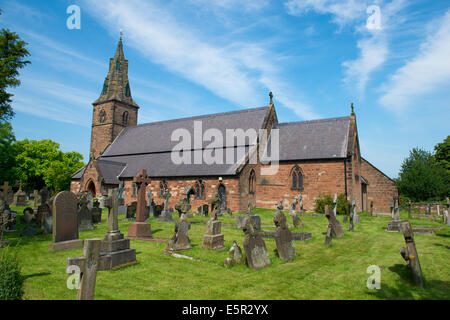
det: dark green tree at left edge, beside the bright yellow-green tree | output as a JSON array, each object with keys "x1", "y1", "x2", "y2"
[{"x1": 0, "y1": 122, "x2": 16, "y2": 184}]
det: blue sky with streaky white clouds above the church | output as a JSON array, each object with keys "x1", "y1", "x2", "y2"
[{"x1": 0, "y1": 0, "x2": 450, "y2": 177}]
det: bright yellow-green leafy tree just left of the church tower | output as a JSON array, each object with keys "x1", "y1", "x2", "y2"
[{"x1": 12, "y1": 139, "x2": 84, "y2": 192}]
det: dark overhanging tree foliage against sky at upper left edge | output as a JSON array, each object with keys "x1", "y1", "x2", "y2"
[{"x1": 0, "y1": 20, "x2": 31, "y2": 122}]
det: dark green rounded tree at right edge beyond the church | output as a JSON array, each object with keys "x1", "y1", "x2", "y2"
[{"x1": 396, "y1": 148, "x2": 450, "y2": 201}]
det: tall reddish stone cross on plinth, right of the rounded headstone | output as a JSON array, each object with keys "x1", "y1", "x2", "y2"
[{"x1": 128, "y1": 169, "x2": 152, "y2": 239}]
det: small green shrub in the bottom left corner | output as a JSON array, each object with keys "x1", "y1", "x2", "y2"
[{"x1": 0, "y1": 249, "x2": 24, "y2": 300}]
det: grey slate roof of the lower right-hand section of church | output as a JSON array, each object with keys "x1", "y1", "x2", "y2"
[{"x1": 274, "y1": 117, "x2": 350, "y2": 161}]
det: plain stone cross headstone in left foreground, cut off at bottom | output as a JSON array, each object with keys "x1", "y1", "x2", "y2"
[{"x1": 66, "y1": 239, "x2": 102, "y2": 300}]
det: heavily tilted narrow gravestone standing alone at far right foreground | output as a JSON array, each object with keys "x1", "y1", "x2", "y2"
[{"x1": 400, "y1": 221, "x2": 423, "y2": 287}]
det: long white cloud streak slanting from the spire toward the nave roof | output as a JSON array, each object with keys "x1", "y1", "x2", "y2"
[{"x1": 83, "y1": 0, "x2": 320, "y2": 120}]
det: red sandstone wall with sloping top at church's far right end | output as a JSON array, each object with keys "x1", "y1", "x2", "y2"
[{"x1": 361, "y1": 159, "x2": 398, "y2": 213}]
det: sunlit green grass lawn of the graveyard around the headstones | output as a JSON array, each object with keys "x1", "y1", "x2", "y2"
[{"x1": 0, "y1": 207, "x2": 450, "y2": 300}]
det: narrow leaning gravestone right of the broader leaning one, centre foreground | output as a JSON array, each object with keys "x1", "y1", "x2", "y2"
[{"x1": 273, "y1": 210, "x2": 295, "y2": 262}]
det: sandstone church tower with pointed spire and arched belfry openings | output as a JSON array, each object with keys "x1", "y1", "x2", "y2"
[{"x1": 89, "y1": 36, "x2": 139, "y2": 159}]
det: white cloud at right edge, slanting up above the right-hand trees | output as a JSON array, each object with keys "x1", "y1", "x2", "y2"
[{"x1": 380, "y1": 10, "x2": 450, "y2": 110}]
